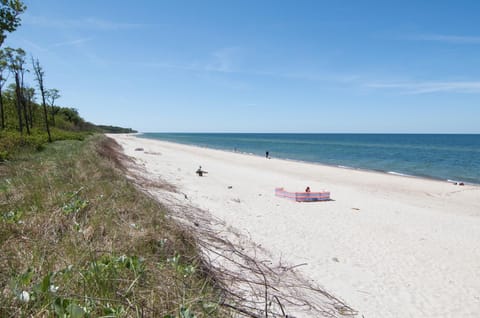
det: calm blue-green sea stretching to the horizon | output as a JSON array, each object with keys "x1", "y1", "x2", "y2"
[{"x1": 140, "y1": 133, "x2": 480, "y2": 184}]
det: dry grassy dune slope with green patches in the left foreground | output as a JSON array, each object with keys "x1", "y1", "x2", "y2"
[{"x1": 0, "y1": 135, "x2": 227, "y2": 318}]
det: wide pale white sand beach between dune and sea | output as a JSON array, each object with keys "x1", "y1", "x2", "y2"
[{"x1": 110, "y1": 135, "x2": 480, "y2": 318}]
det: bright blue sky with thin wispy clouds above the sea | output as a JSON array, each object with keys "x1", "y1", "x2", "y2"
[{"x1": 4, "y1": 0, "x2": 480, "y2": 133}]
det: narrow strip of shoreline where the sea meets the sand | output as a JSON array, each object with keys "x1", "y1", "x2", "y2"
[{"x1": 136, "y1": 133, "x2": 480, "y2": 187}]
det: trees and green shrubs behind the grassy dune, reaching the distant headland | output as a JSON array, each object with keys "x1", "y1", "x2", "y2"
[{"x1": 0, "y1": 0, "x2": 133, "y2": 162}]
